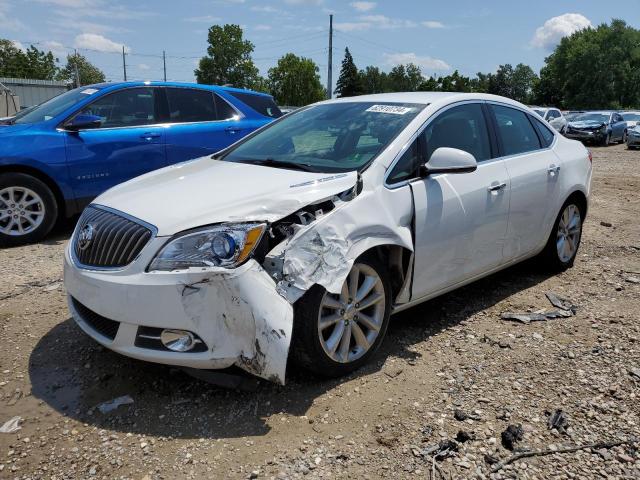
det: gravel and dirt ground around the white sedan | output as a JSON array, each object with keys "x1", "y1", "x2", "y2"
[{"x1": 0, "y1": 146, "x2": 640, "y2": 480}]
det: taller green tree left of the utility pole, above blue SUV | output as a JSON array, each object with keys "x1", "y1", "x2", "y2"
[{"x1": 194, "y1": 24, "x2": 258, "y2": 88}]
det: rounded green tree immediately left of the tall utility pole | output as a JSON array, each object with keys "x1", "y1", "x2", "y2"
[{"x1": 269, "y1": 53, "x2": 326, "y2": 106}]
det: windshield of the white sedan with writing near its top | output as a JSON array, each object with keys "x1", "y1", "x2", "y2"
[{"x1": 222, "y1": 102, "x2": 426, "y2": 172}]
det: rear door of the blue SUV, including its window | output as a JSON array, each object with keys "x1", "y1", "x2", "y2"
[{"x1": 165, "y1": 87, "x2": 249, "y2": 164}]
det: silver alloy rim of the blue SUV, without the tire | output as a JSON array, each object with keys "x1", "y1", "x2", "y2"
[{"x1": 0, "y1": 187, "x2": 45, "y2": 237}]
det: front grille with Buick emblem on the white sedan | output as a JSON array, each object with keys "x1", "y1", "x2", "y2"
[{"x1": 73, "y1": 206, "x2": 153, "y2": 268}]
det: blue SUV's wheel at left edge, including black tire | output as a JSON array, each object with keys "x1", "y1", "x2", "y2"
[{"x1": 0, "y1": 173, "x2": 58, "y2": 247}]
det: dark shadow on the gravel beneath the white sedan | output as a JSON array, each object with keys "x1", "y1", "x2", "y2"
[{"x1": 29, "y1": 262, "x2": 549, "y2": 438}]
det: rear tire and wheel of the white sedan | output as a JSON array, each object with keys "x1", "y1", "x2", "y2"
[{"x1": 541, "y1": 199, "x2": 584, "y2": 271}]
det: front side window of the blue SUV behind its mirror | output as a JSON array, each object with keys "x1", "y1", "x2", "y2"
[{"x1": 80, "y1": 87, "x2": 157, "y2": 128}]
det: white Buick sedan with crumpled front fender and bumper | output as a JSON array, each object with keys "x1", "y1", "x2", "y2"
[{"x1": 64, "y1": 92, "x2": 591, "y2": 383}]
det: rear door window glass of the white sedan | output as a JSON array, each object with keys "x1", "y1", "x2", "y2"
[{"x1": 491, "y1": 105, "x2": 540, "y2": 156}]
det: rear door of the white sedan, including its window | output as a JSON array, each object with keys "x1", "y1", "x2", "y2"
[{"x1": 490, "y1": 104, "x2": 562, "y2": 259}]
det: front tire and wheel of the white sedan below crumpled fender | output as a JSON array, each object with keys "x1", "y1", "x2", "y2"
[{"x1": 291, "y1": 257, "x2": 391, "y2": 377}]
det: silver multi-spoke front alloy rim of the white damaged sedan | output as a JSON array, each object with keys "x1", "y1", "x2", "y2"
[{"x1": 318, "y1": 263, "x2": 386, "y2": 363}]
